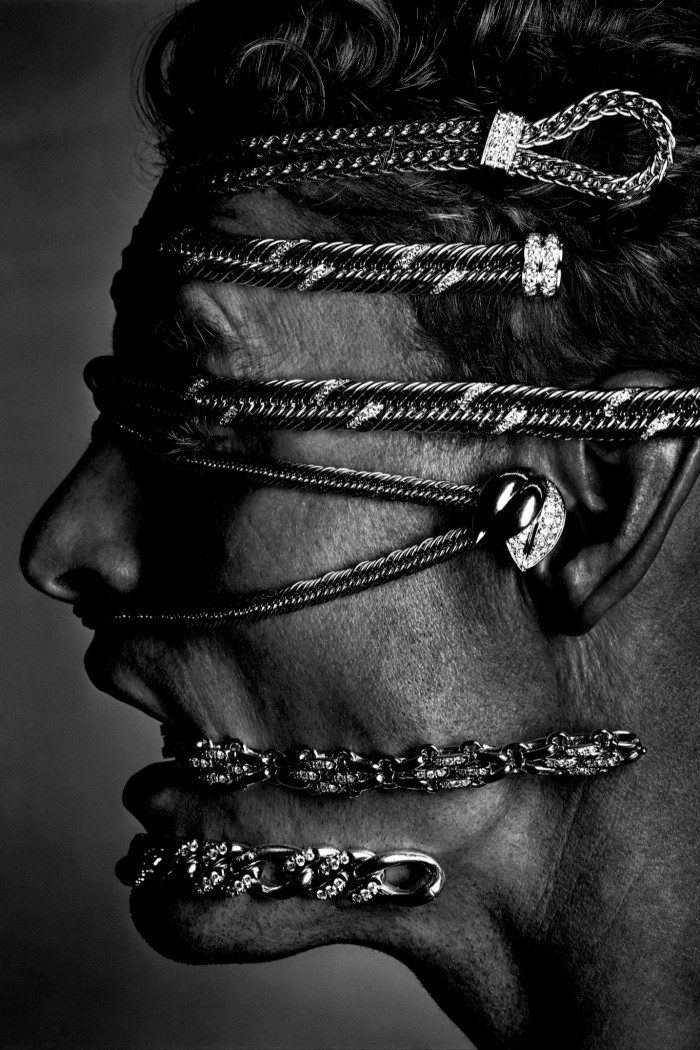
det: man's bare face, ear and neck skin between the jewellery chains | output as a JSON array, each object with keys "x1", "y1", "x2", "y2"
[{"x1": 23, "y1": 192, "x2": 700, "y2": 1048}]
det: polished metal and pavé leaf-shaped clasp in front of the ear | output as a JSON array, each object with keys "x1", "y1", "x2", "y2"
[{"x1": 474, "y1": 471, "x2": 566, "y2": 572}]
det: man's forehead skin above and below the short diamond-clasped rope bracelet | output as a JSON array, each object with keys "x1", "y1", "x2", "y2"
[{"x1": 158, "y1": 191, "x2": 430, "y2": 380}]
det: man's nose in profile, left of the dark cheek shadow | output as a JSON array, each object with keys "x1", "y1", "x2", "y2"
[{"x1": 20, "y1": 443, "x2": 141, "y2": 603}]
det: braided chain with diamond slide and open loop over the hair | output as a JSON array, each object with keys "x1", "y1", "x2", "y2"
[{"x1": 165, "y1": 89, "x2": 675, "y2": 203}]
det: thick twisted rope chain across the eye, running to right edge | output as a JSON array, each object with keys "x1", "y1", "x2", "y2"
[{"x1": 86, "y1": 358, "x2": 700, "y2": 441}]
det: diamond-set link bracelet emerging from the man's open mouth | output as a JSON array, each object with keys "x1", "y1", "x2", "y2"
[{"x1": 162, "y1": 727, "x2": 646, "y2": 797}]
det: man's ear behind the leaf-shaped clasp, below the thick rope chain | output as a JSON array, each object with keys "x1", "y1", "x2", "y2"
[{"x1": 523, "y1": 372, "x2": 700, "y2": 634}]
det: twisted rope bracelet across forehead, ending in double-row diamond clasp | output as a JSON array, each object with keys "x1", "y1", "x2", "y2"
[{"x1": 146, "y1": 229, "x2": 561, "y2": 298}]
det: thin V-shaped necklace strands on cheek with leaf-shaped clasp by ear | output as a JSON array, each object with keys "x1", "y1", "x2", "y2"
[{"x1": 80, "y1": 392, "x2": 564, "y2": 628}]
